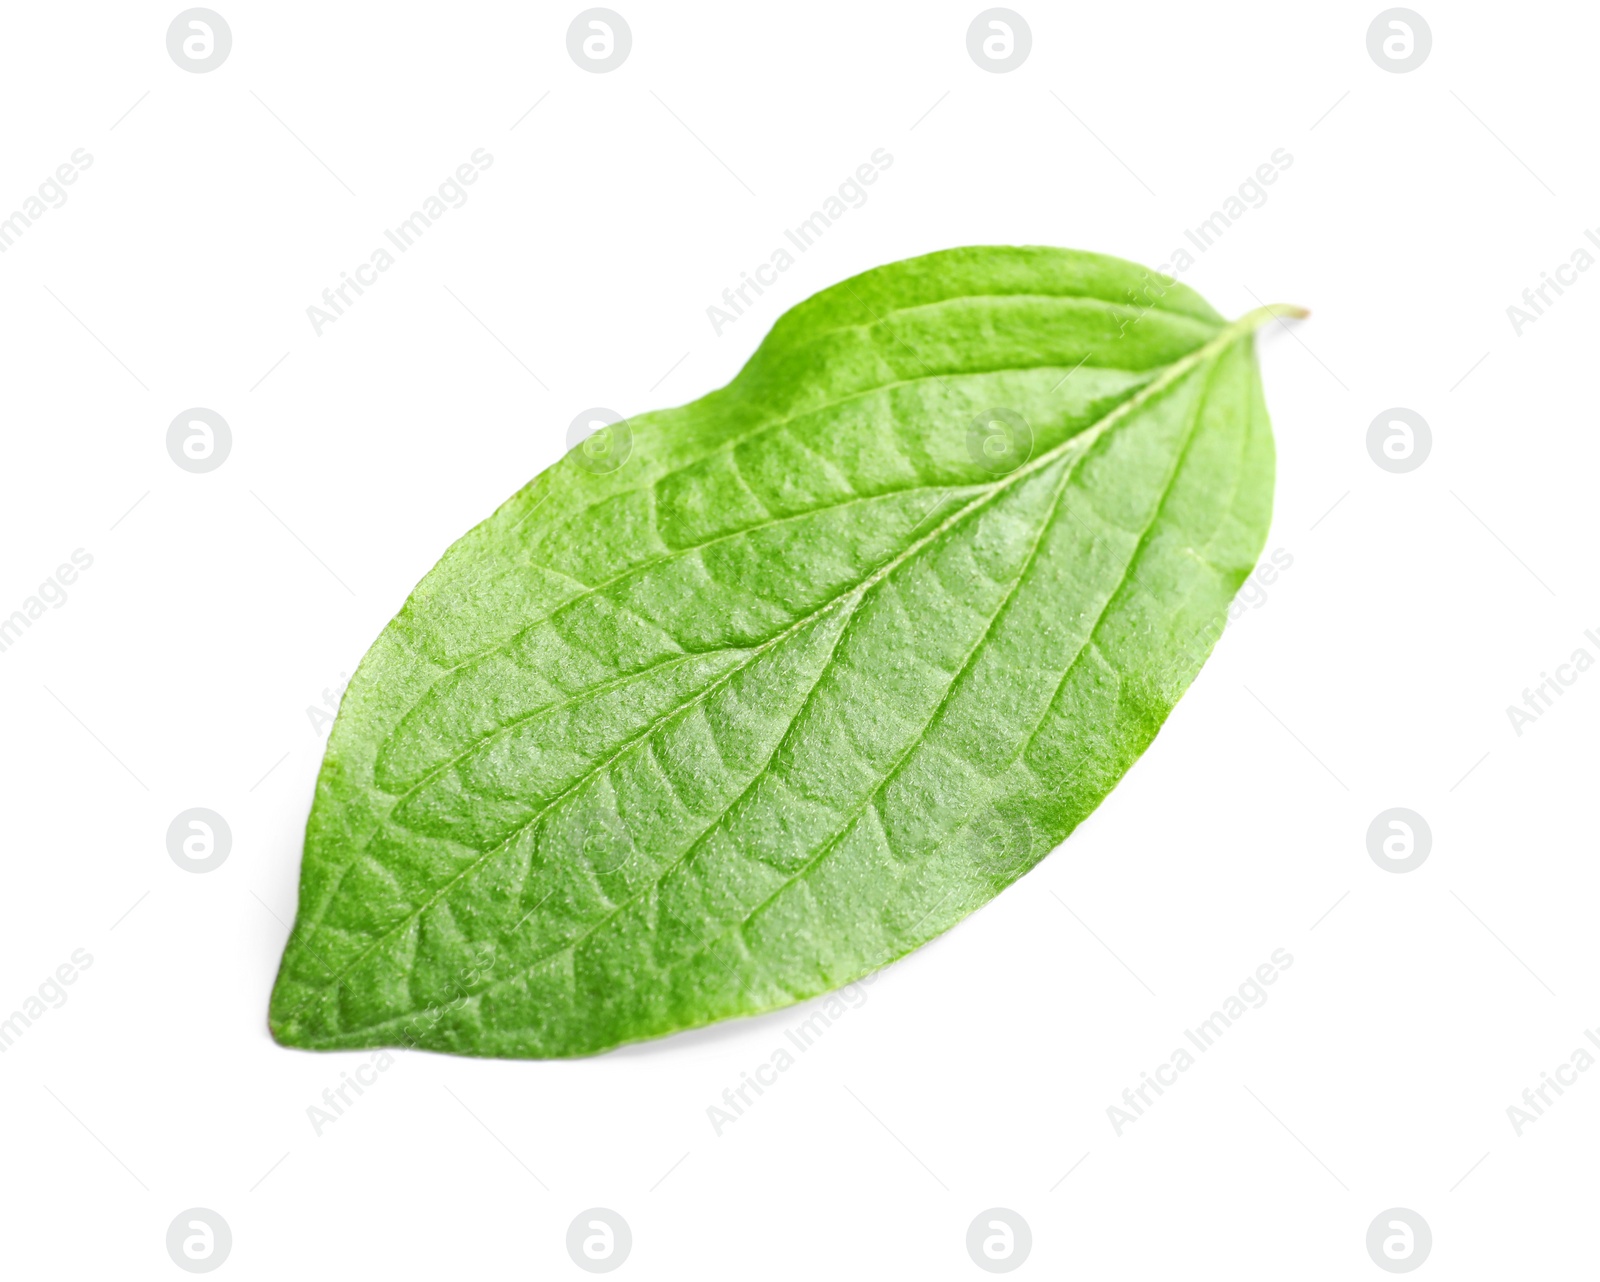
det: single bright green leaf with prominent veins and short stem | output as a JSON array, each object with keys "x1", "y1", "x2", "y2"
[{"x1": 270, "y1": 248, "x2": 1296, "y2": 1058}]
